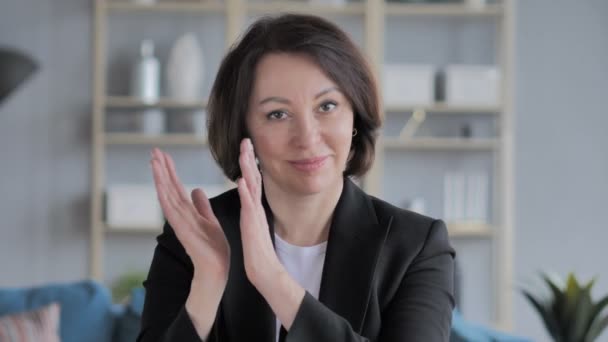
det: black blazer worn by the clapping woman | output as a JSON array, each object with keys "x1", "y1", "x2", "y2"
[{"x1": 137, "y1": 178, "x2": 454, "y2": 342}]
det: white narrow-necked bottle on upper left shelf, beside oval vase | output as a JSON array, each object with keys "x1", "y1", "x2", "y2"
[{"x1": 131, "y1": 39, "x2": 160, "y2": 103}]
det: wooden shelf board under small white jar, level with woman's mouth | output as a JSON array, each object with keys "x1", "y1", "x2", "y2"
[{"x1": 105, "y1": 133, "x2": 207, "y2": 146}]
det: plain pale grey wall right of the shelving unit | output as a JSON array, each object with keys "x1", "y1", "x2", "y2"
[{"x1": 515, "y1": 0, "x2": 608, "y2": 341}]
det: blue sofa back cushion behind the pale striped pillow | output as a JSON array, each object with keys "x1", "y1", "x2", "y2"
[{"x1": 0, "y1": 280, "x2": 114, "y2": 342}]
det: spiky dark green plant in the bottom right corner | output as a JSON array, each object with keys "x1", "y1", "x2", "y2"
[{"x1": 522, "y1": 273, "x2": 608, "y2": 342}]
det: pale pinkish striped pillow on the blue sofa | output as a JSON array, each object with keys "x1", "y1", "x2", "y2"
[{"x1": 0, "y1": 303, "x2": 60, "y2": 342}]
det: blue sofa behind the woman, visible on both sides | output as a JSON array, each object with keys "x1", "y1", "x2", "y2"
[{"x1": 0, "y1": 280, "x2": 529, "y2": 342}]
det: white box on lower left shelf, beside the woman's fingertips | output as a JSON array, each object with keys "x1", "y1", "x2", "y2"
[{"x1": 106, "y1": 184, "x2": 163, "y2": 230}]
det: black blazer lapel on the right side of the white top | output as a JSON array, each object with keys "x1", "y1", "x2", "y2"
[{"x1": 319, "y1": 178, "x2": 390, "y2": 333}]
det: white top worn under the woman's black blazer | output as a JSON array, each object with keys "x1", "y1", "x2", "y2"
[{"x1": 274, "y1": 234, "x2": 327, "y2": 342}]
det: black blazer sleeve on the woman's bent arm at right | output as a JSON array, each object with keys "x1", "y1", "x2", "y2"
[{"x1": 285, "y1": 220, "x2": 454, "y2": 342}]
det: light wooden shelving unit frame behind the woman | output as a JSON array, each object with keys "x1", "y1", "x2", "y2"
[{"x1": 90, "y1": 0, "x2": 515, "y2": 329}]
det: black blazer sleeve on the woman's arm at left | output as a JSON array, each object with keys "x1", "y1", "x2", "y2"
[{"x1": 137, "y1": 223, "x2": 220, "y2": 342}]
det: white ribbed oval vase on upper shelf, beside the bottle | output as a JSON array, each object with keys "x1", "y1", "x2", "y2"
[{"x1": 166, "y1": 33, "x2": 205, "y2": 101}]
